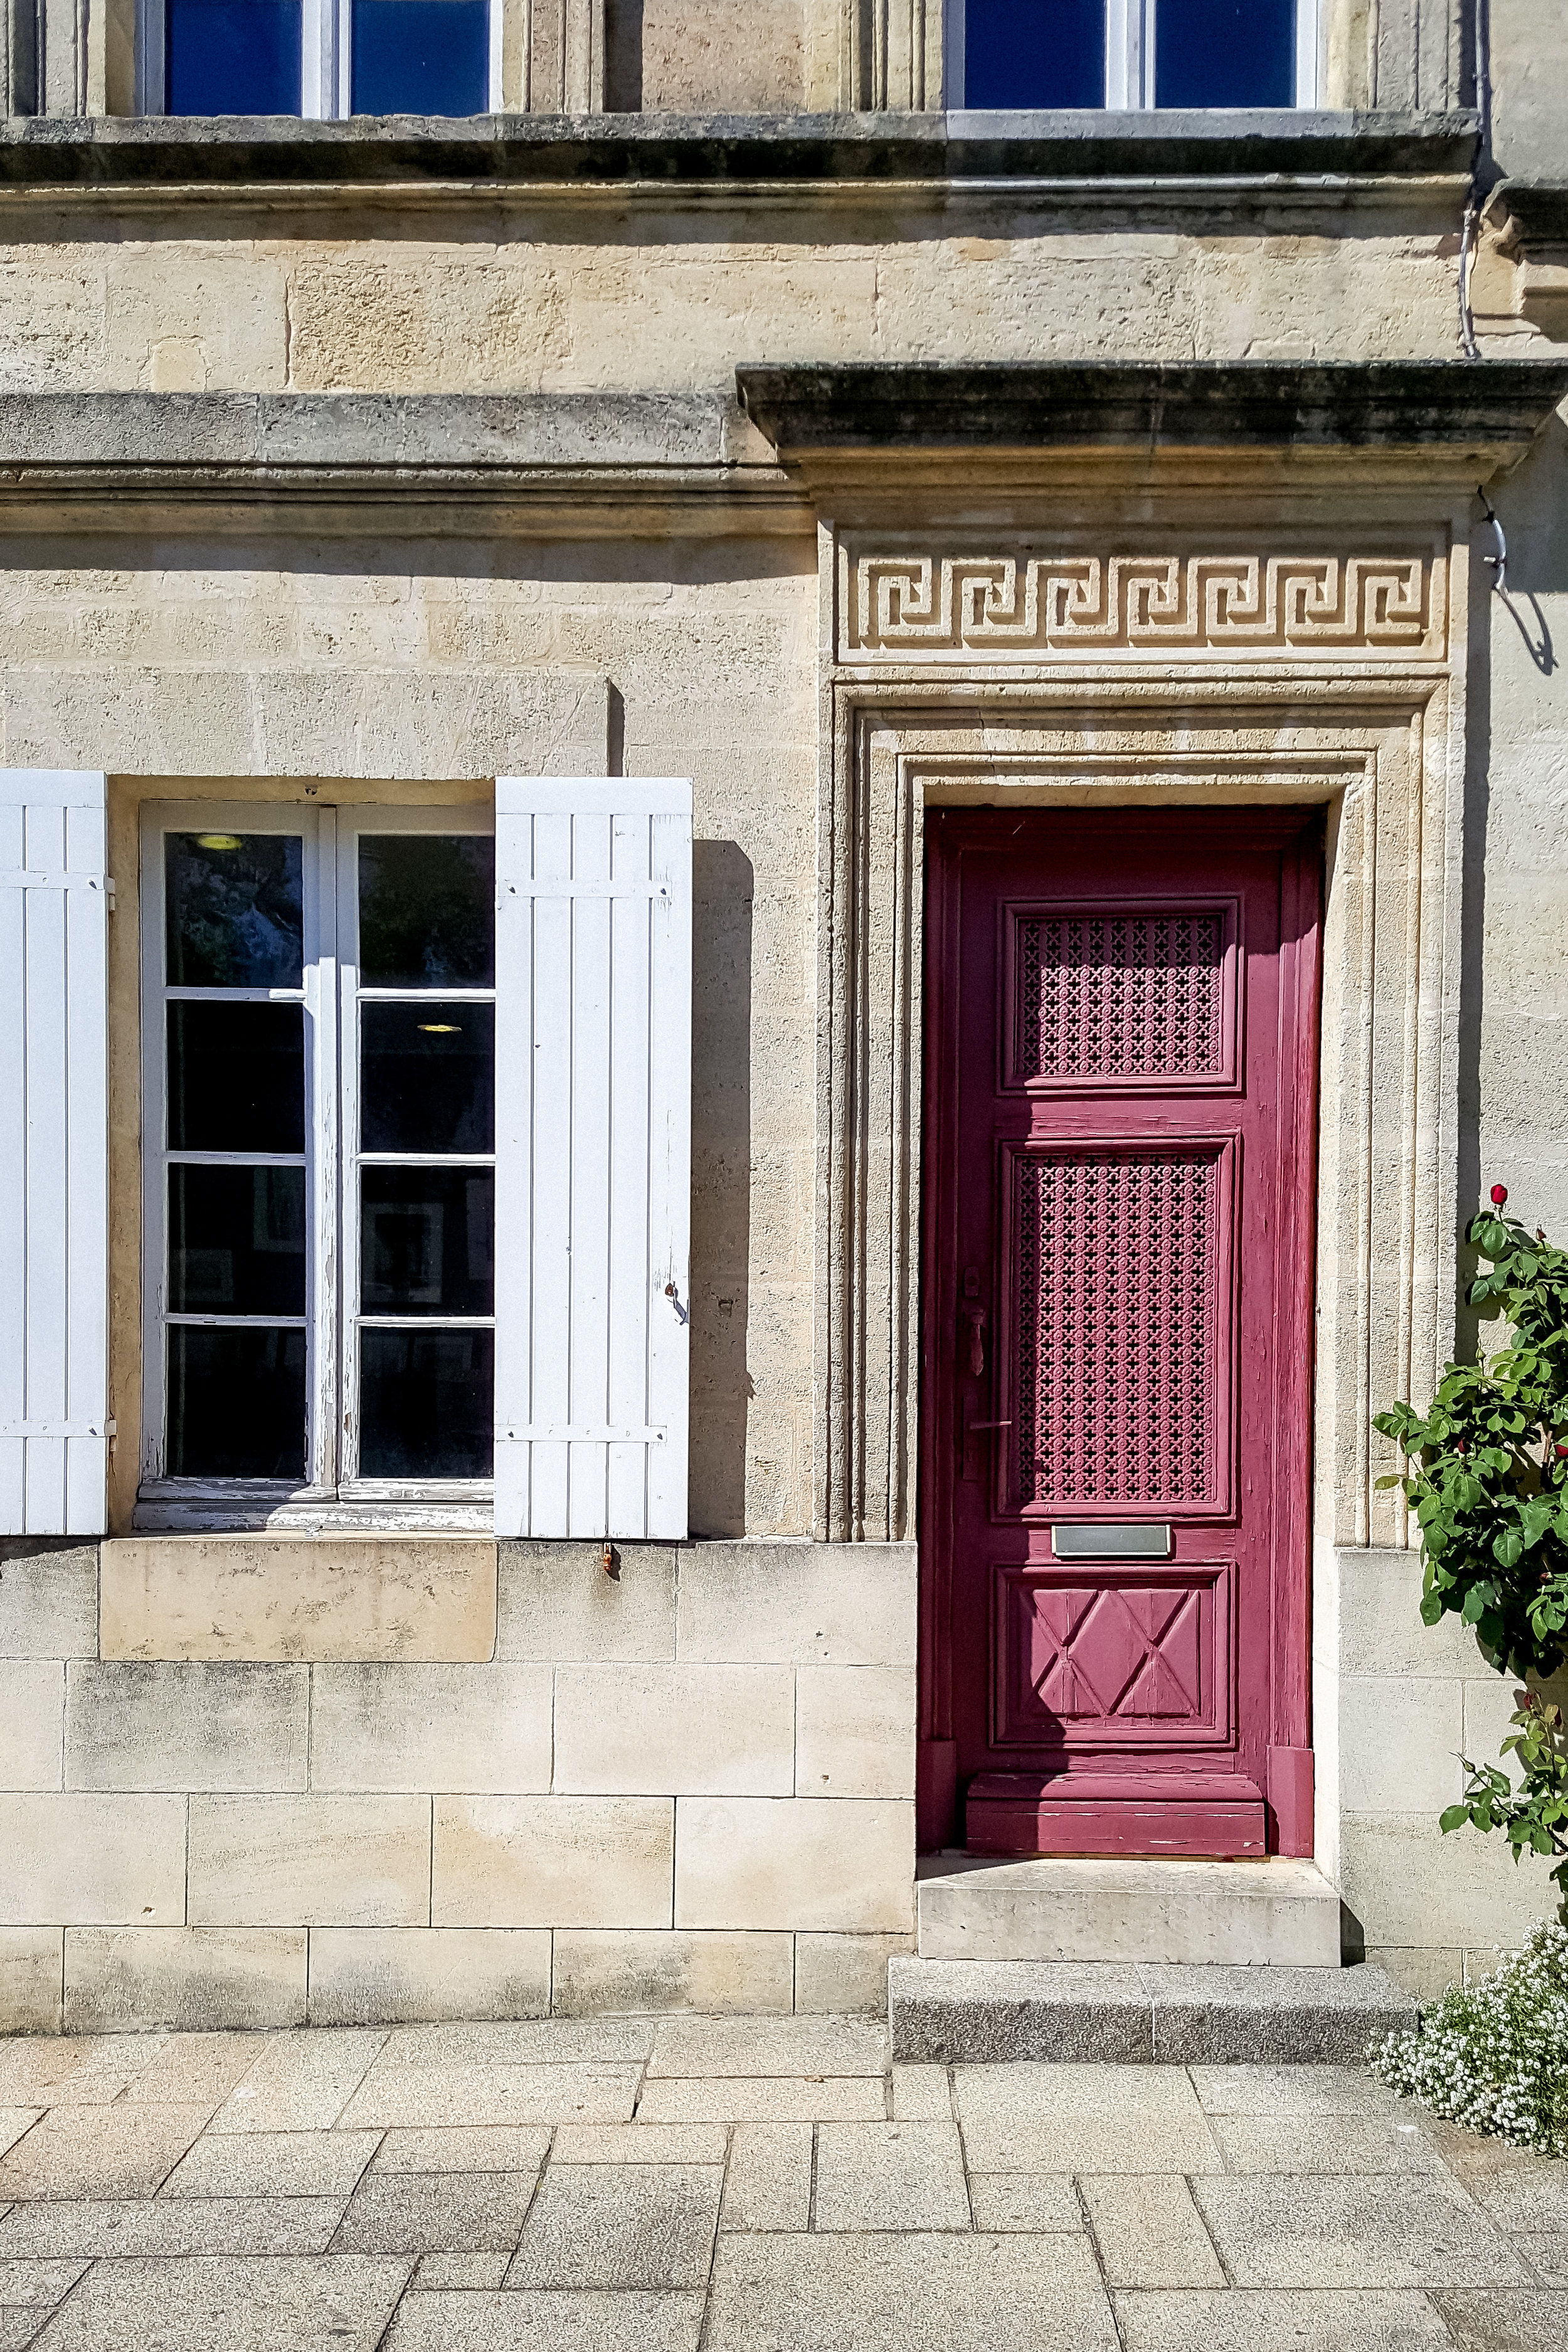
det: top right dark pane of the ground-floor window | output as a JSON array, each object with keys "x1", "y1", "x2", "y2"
[{"x1": 359, "y1": 833, "x2": 496, "y2": 988}]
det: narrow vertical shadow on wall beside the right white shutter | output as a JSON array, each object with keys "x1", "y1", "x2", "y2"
[{"x1": 691, "y1": 842, "x2": 755, "y2": 1536}]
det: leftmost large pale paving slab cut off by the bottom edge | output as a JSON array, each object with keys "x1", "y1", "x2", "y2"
[{"x1": 29, "y1": 2255, "x2": 411, "y2": 2352}]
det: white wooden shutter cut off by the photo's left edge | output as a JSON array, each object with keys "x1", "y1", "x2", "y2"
[{"x1": 0, "y1": 767, "x2": 110, "y2": 1536}]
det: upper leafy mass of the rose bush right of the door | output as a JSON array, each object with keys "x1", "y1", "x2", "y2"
[{"x1": 1375, "y1": 1185, "x2": 1568, "y2": 1680}]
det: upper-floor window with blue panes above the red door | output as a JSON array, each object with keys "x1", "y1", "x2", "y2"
[{"x1": 947, "y1": 0, "x2": 1316, "y2": 109}]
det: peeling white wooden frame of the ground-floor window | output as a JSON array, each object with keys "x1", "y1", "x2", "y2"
[{"x1": 136, "y1": 800, "x2": 494, "y2": 1534}]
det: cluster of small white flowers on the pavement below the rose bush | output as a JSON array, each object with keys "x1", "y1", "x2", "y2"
[{"x1": 1370, "y1": 1922, "x2": 1568, "y2": 2157}]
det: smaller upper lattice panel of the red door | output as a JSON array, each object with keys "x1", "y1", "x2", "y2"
[{"x1": 1013, "y1": 908, "x2": 1227, "y2": 1084}]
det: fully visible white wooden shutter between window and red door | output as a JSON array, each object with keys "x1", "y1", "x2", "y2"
[{"x1": 496, "y1": 776, "x2": 691, "y2": 1540}]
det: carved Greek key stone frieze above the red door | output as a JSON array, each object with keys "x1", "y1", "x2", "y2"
[{"x1": 839, "y1": 548, "x2": 1443, "y2": 661}]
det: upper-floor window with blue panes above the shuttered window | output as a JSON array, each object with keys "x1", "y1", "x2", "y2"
[{"x1": 139, "y1": 0, "x2": 501, "y2": 118}]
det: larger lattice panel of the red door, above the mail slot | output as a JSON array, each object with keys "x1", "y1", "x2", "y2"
[{"x1": 1013, "y1": 1145, "x2": 1222, "y2": 1510}]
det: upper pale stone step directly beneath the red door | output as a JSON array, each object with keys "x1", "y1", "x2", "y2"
[{"x1": 914, "y1": 1853, "x2": 1340, "y2": 1969}]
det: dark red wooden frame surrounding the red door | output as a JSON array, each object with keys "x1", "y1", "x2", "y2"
[{"x1": 917, "y1": 800, "x2": 1323, "y2": 1856}]
